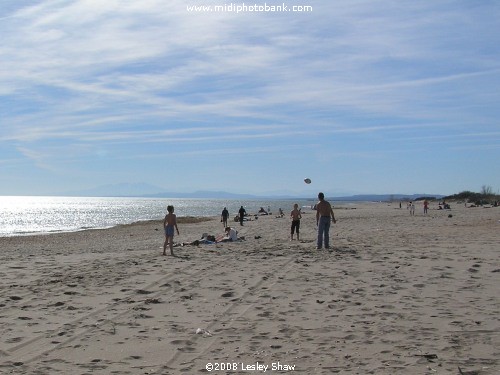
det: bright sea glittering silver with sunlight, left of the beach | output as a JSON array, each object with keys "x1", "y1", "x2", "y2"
[{"x1": 0, "y1": 196, "x2": 315, "y2": 237}]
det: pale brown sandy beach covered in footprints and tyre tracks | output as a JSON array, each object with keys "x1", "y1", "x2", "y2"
[{"x1": 0, "y1": 202, "x2": 500, "y2": 375}]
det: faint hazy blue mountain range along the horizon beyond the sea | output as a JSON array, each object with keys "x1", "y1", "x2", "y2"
[{"x1": 57, "y1": 183, "x2": 443, "y2": 202}]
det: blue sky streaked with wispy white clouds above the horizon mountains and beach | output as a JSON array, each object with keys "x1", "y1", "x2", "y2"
[{"x1": 0, "y1": 0, "x2": 500, "y2": 196}]
